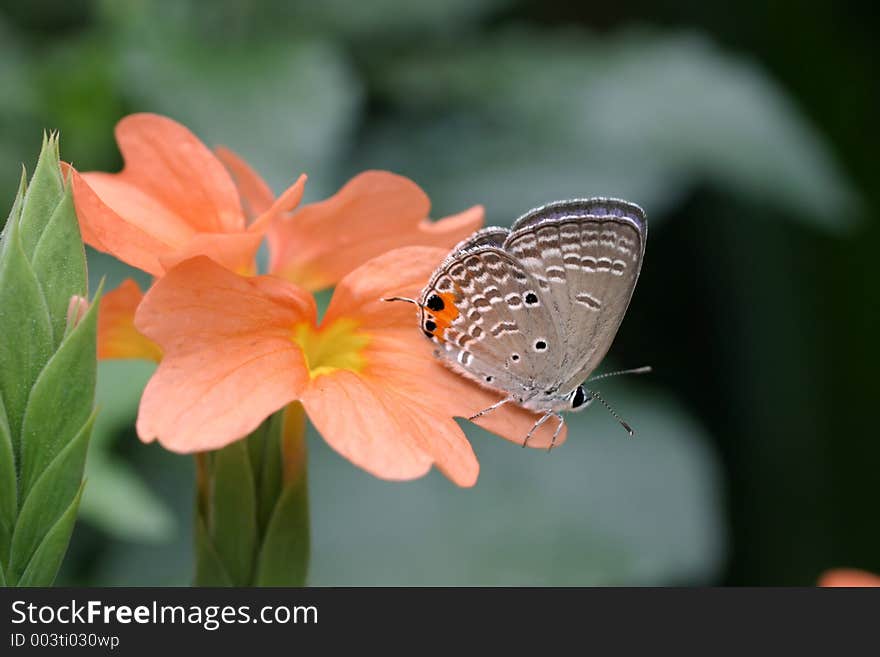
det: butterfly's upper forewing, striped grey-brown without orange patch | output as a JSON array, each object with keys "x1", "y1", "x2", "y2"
[{"x1": 504, "y1": 199, "x2": 647, "y2": 392}]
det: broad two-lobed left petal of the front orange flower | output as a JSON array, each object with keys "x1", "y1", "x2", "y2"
[{"x1": 135, "y1": 256, "x2": 315, "y2": 452}]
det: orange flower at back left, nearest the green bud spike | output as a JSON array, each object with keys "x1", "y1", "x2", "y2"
[{"x1": 70, "y1": 114, "x2": 305, "y2": 276}]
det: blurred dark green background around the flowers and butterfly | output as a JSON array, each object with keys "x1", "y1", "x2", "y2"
[{"x1": 0, "y1": 0, "x2": 880, "y2": 585}]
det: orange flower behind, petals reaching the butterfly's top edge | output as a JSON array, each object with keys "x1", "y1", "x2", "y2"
[{"x1": 216, "y1": 148, "x2": 484, "y2": 291}]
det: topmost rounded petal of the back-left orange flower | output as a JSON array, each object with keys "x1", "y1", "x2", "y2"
[{"x1": 115, "y1": 114, "x2": 245, "y2": 233}]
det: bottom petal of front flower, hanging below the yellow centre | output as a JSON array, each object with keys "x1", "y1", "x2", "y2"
[{"x1": 302, "y1": 370, "x2": 479, "y2": 486}]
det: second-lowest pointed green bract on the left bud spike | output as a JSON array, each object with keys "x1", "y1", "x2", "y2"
[{"x1": 9, "y1": 413, "x2": 95, "y2": 577}]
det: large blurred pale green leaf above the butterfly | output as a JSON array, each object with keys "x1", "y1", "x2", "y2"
[{"x1": 361, "y1": 29, "x2": 861, "y2": 230}]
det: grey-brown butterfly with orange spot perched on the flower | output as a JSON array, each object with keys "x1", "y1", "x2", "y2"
[{"x1": 388, "y1": 198, "x2": 650, "y2": 448}]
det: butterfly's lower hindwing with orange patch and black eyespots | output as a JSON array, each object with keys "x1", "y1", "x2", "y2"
[{"x1": 420, "y1": 245, "x2": 564, "y2": 401}]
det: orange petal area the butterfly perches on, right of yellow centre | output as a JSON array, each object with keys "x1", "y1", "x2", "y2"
[{"x1": 324, "y1": 246, "x2": 567, "y2": 448}]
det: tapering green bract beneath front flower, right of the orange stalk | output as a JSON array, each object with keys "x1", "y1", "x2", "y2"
[{"x1": 253, "y1": 477, "x2": 310, "y2": 586}]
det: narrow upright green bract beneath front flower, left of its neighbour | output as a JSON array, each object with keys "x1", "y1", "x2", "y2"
[{"x1": 206, "y1": 440, "x2": 258, "y2": 586}]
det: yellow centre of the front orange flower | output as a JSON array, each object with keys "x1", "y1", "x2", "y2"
[{"x1": 293, "y1": 318, "x2": 370, "y2": 379}]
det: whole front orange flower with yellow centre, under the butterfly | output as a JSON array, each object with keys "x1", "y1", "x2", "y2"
[{"x1": 136, "y1": 247, "x2": 565, "y2": 486}]
